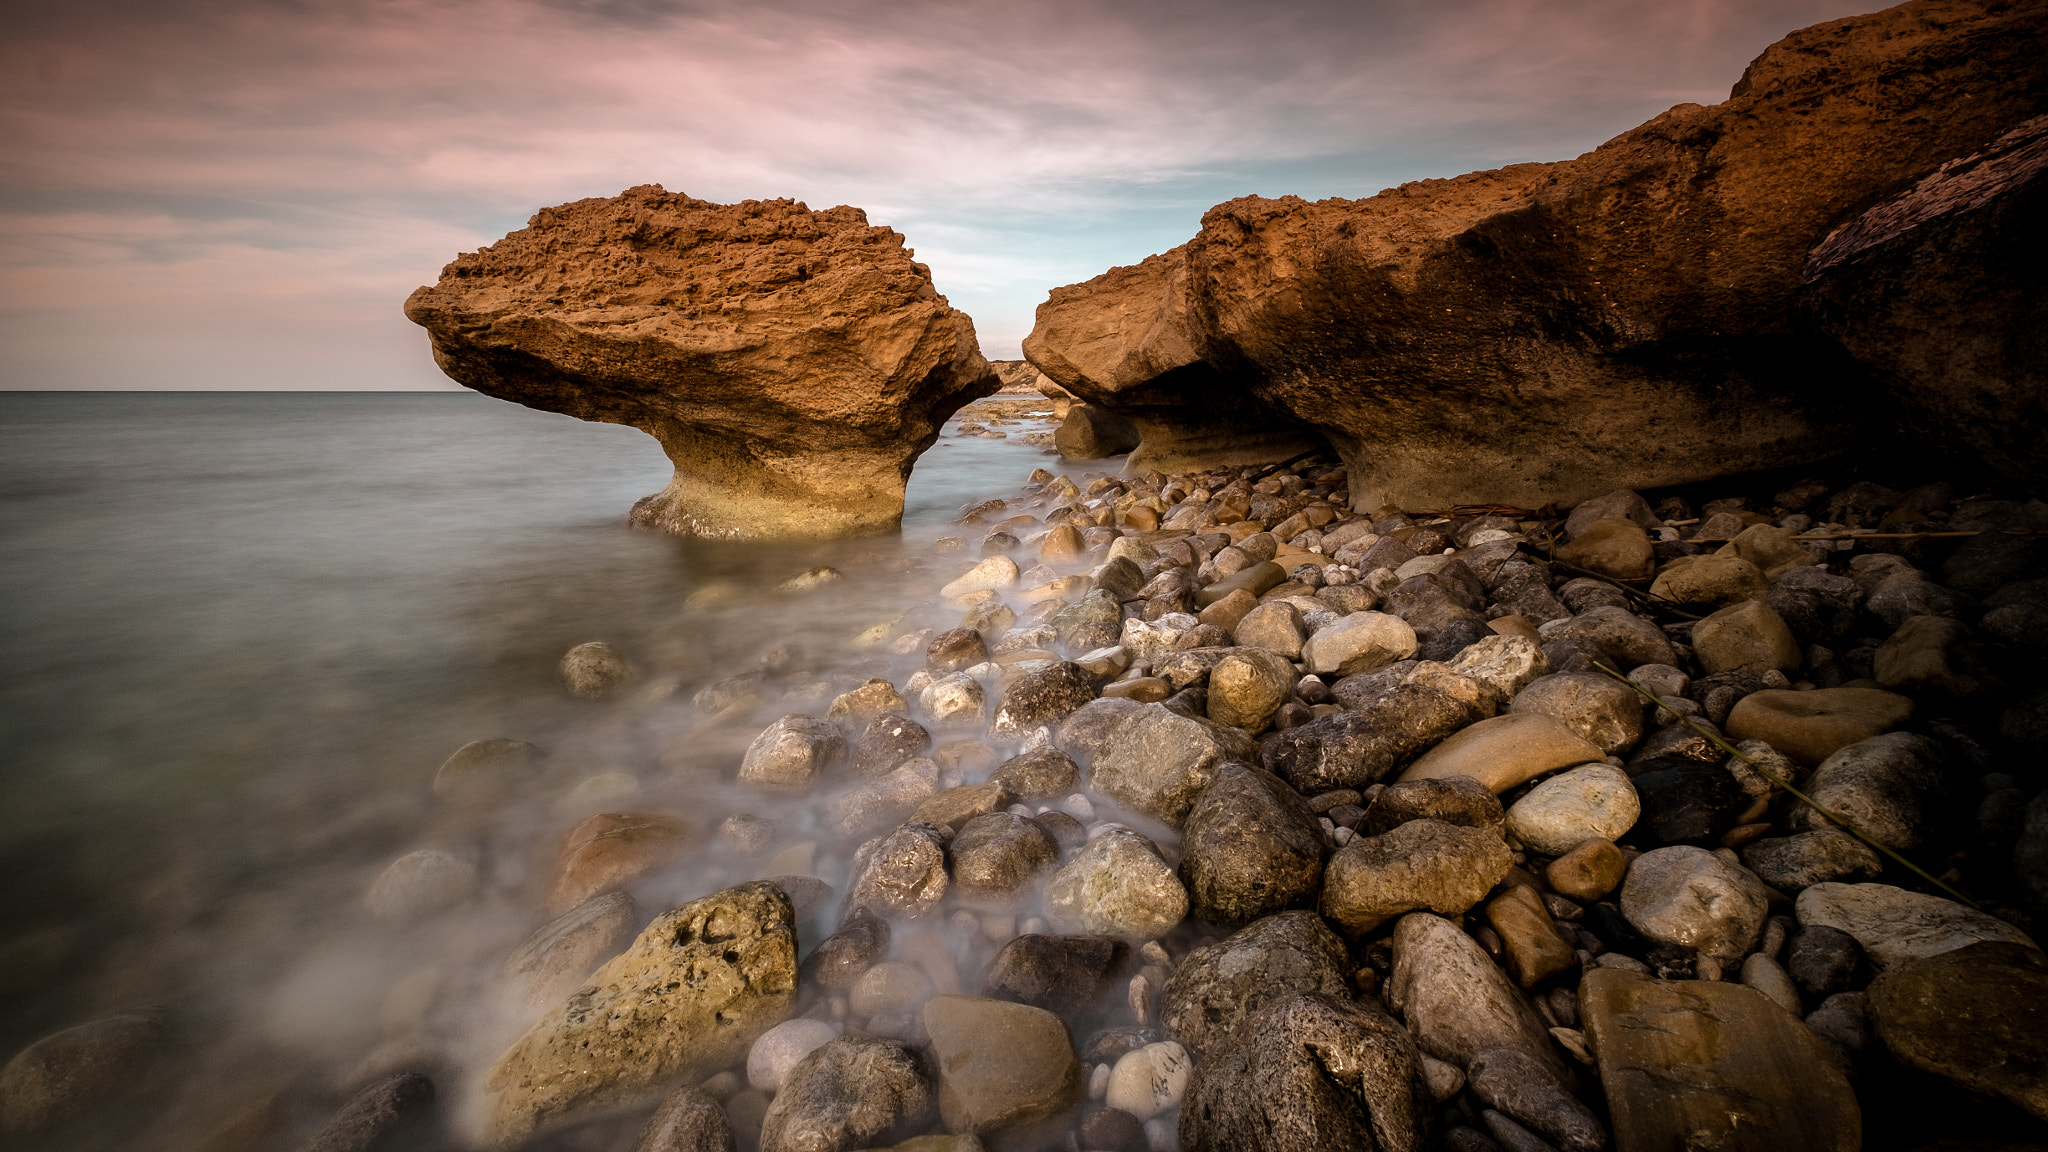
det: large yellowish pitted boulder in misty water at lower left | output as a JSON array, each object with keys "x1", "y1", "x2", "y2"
[{"x1": 483, "y1": 881, "x2": 797, "y2": 1148}]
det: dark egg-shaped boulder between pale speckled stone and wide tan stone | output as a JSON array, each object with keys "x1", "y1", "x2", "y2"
[{"x1": 1180, "y1": 765, "x2": 1323, "y2": 929}]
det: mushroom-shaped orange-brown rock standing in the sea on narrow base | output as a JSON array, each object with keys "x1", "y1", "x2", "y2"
[{"x1": 406, "y1": 184, "x2": 997, "y2": 539}]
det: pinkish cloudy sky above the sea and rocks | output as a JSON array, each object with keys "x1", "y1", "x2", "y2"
[{"x1": 0, "y1": 0, "x2": 1878, "y2": 389}]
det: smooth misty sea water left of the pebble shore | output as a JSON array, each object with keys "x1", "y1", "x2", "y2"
[{"x1": 0, "y1": 394, "x2": 1051, "y2": 1148}]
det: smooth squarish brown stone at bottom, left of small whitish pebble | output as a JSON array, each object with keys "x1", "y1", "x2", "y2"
[{"x1": 920, "y1": 996, "x2": 1081, "y2": 1136}]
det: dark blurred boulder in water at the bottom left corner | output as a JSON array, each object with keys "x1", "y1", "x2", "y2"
[{"x1": 0, "y1": 1011, "x2": 170, "y2": 1136}]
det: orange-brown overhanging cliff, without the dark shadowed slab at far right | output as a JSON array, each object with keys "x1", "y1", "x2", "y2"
[{"x1": 1024, "y1": 0, "x2": 2048, "y2": 508}]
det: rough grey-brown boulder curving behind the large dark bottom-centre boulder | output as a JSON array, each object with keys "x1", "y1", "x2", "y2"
[{"x1": 1159, "y1": 912, "x2": 1350, "y2": 1060}]
